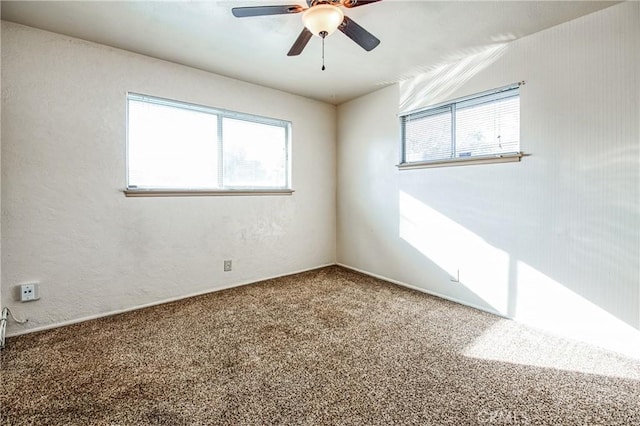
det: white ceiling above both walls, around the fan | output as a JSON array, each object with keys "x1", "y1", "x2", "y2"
[{"x1": 2, "y1": 0, "x2": 616, "y2": 104}]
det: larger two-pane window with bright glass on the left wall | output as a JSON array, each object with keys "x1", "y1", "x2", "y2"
[{"x1": 126, "y1": 93, "x2": 291, "y2": 195}]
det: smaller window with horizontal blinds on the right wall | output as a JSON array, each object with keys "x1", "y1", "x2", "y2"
[{"x1": 399, "y1": 85, "x2": 522, "y2": 169}]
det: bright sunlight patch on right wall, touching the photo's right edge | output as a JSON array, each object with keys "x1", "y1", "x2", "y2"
[{"x1": 515, "y1": 261, "x2": 640, "y2": 359}]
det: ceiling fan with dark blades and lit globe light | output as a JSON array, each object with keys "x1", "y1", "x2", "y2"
[{"x1": 231, "y1": 0, "x2": 381, "y2": 70}]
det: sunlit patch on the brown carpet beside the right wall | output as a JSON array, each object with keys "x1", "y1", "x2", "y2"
[{"x1": 463, "y1": 320, "x2": 640, "y2": 380}]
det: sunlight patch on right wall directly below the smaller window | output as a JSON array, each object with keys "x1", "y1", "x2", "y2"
[{"x1": 399, "y1": 191, "x2": 509, "y2": 315}]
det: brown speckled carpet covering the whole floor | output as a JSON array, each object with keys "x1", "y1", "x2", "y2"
[{"x1": 0, "y1": 267, "x2": 640, "y2": 425}]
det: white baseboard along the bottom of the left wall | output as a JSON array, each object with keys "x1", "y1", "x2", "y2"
[{"x1": 6, "y1": 263, "x2": 336, "y2": 337}]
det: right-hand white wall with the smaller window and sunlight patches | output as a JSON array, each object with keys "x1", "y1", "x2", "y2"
[{"x1": 338, "y1": 2, "x2": 640, "y2": 357}]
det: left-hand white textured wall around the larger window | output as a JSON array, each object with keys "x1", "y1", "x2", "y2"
[{"x1": 2, "y1": 22, "x2": 336, "y2": 334}]
